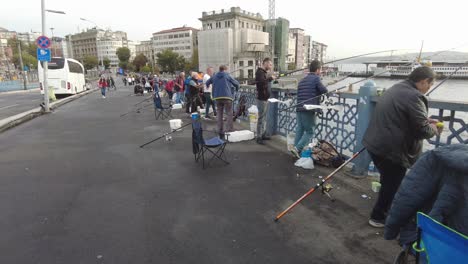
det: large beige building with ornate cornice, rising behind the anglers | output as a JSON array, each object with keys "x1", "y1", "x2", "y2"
[{"x1": 198, "y1": 7, "x2": 270, "y2": 79}]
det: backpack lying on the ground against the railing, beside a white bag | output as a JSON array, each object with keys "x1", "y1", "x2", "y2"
[{"x1": 312, "y1": 140, "x2": 345, "y2": 168}]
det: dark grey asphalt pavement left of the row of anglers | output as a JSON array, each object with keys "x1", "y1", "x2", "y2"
[{"x1": 0, "y1": 81, "x2": 398, "y2": 264}]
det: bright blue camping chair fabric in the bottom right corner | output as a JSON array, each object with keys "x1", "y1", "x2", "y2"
[{"x1": 395, "y1": 212, "x2": 468, "y2": 264}]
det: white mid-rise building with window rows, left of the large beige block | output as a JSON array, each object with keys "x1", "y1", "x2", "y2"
[{"x1": 152, "y1": 26, "x2": 198, "y2": 59}]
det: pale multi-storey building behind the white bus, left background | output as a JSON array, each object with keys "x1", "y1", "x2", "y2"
[{"x1": 69, "y1": 28, "x2": 128, "y2": 67}]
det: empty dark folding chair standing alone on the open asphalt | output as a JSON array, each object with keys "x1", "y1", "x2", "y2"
[{"x1": 192, "y1": 118, "x2": 229, "y2": 169}]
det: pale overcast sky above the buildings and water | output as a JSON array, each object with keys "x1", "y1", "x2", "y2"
[{"x1": 0, "y1": 0, "x2": 468, "y2": 58}]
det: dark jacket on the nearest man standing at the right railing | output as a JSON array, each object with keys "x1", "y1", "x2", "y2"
[{"x1": 362, "y1": 80, "x2": 435, "y2": 168}]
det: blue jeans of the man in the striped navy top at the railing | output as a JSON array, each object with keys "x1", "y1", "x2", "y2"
[{"x1": 294, "y1": 111, "x2": 317, "y2": 151}]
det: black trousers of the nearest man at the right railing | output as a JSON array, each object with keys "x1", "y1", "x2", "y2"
[{"x1": 369, "y1": 152, "x2": 406, "y2": 221}]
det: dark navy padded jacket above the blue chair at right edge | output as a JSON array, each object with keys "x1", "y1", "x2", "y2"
[{"x1": 384, "y1": 144, "x2": 468, "y2": 245}]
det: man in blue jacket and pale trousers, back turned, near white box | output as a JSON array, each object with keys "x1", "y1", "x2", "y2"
[{"x1": 206, "y1": 65, "x2": 239, "y2": 138}]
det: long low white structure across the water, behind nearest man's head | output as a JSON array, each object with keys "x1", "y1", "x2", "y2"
[{"x1": 364, "y1": 60, "x2": 468, "y2": 79}]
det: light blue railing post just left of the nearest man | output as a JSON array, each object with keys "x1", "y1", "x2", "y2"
[{"x1": 350, "y1": 81, "x2": 377, "y2": 177}]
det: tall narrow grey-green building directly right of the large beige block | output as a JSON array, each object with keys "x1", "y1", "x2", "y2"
[{"x1": 265, "y1": 18, "x2": 289, "y2": 72}]
